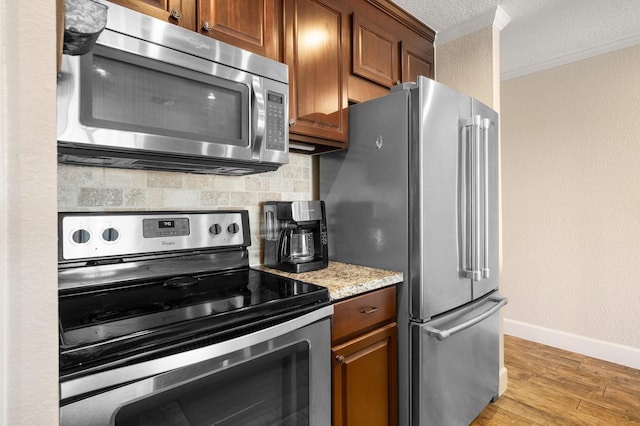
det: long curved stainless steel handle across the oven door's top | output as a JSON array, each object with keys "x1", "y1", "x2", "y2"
[{"x1": 60, "y1": 305, "x2": 333, "y2": 403}]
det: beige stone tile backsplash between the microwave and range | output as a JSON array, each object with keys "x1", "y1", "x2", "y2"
[{"x1": 58, "y1": 154, "x2": 312, "y2": 265}]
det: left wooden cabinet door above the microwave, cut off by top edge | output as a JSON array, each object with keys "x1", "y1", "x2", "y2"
[{"x1": 111, "y1": 0, "x2": 196, "y2": 30}]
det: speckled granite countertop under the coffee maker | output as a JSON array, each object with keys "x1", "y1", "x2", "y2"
[{"x1": 255, "y1": 262, "x2": 403, "y2": 302}]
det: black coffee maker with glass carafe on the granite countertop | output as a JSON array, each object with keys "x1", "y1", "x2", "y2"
[{"x1": 263, "y1": 201, "x2": 329, "y2": 272}]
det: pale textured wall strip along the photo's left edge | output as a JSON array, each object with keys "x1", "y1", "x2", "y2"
[{"x1": 0, "y1": 0, "x2": 58, "y2": 426}]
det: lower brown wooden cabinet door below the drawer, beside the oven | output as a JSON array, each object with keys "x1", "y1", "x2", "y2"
[{"x1": 332, "y1": 322, "x2": 398, "y2": 426}]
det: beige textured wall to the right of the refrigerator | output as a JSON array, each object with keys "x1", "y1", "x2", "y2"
[{"x1": 501, "y1": 46, "x2": 640, "y2": 348}]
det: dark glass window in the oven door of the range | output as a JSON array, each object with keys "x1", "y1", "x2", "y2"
[{"x1": 114, "y1": 342, "x2": 310, "y2": 426}]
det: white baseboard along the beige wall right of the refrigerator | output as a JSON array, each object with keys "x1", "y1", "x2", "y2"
[{"x1": 503, "y1": 318, "x2": 640, "y2": 369}]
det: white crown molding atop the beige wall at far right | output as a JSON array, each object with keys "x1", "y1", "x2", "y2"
[{"x1": 500, "y1": 33, "x2": 640, "y2": 81}]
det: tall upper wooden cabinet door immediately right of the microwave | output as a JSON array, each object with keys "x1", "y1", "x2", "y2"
[{"x1": 284, "y1": 0, "x2": 349, "y2": 147}]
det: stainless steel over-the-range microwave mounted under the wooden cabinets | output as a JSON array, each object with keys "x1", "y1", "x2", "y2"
[{"x1": 57, "y1": 1, "x2": 289, "y2": 175}]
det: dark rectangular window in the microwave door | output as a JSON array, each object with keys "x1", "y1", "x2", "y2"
[{"x1": 80, "y1": 46, "x2": 249, "y2": 146}]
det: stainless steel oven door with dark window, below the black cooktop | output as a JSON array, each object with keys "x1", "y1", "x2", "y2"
[{"x1": 60, "y1": 306, "x2": 333, "y2": 426}]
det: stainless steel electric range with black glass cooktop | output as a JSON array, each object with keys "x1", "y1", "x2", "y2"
[{"x1": 58, "y1": 210, "x2": 333, "y2": 426}]
